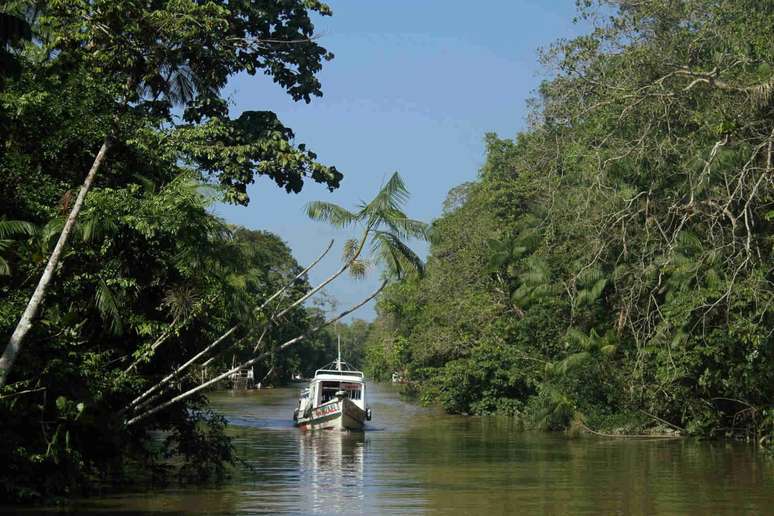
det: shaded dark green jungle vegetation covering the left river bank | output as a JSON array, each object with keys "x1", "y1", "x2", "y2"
[{"x1": 0, "y1": 0, "x2": 384, "y2": 500}]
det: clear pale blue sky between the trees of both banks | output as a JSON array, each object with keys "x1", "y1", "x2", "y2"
[{"x1": 214, "y1": 0, "x2": 581, "y2": 320}]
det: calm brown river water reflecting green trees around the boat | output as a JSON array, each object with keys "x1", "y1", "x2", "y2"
[{"x1": 27, "y1": 385, "x2": 774, "y2": 515}]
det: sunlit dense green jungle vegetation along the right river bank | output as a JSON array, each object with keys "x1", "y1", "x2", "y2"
[{"x1": 366, "y1": 0, "x2": 774, "y2": 443}]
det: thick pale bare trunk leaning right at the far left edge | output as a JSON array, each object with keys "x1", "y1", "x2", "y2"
[{"x1": 0, "y1": 134, "x2": 112, "y2": 387}]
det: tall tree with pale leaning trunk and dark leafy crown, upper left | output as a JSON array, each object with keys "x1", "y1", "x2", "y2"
[{"x1": 0, "y1": 0, "x2": 342, "y2": 386}]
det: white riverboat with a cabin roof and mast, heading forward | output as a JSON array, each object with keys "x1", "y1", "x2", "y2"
[{"x1": 293, "y1": 338, "x2": 371, "y2": 430}]
